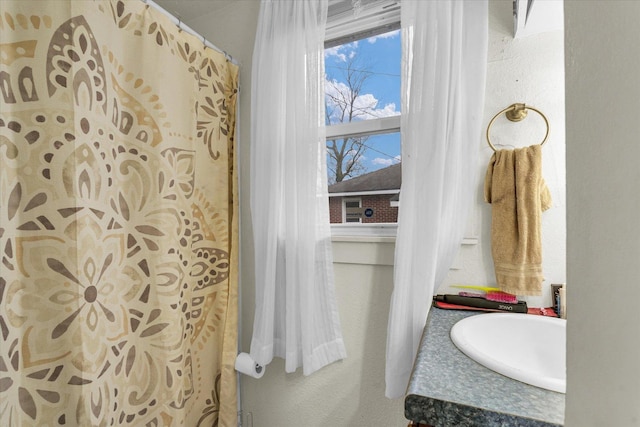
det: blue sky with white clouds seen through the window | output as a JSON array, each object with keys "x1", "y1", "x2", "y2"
[{"x1": 325, "y1": 31, "x2": 401, "y2": 177}]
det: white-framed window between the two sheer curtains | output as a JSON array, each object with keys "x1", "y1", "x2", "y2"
[{"x1": 324, "y1": 0, "x2": 401, "y2": 234}]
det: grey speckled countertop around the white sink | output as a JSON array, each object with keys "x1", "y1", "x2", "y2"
[{"x1": 405, "y1": 308, "x2": 564, "y2": 427}]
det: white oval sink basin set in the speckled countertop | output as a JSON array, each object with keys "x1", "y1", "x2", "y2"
[{"x1": 451, "y1": 313, "x2": 567, "y2": 393}]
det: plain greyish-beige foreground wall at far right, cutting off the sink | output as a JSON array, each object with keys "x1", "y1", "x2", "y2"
[{"x1": 565, "y1": 1, "x2": 640, "y2": 427}]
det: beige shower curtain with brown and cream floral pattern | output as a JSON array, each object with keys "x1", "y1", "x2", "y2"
[{"x1": 0, "y1": 0, "x2": 238, "y2": 426}]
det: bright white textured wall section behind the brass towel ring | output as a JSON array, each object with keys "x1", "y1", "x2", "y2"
[{"x1": 439, "y1": 0, "x2": 566, "y2": 307}]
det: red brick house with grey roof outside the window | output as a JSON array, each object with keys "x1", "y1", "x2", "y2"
[{"x1": 329, "y1": 163, "x2": 402, "y2": 224}]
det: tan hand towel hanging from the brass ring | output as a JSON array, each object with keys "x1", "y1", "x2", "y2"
[{"x1": 484, "y1": 145, "x2": 551, "y2": 295}]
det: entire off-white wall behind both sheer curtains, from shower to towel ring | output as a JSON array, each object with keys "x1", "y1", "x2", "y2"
[{"x1": 187, "y1": 0, "x2": 565, "y2": 427}]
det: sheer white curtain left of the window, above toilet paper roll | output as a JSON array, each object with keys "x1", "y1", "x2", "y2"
[{"x1": 250, "y1": 0, "x2": 346, "y2": 375}]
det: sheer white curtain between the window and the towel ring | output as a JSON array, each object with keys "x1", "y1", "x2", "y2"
[{"x1": 386, "y1": 0, "x2": 488, "y2": 398}]
